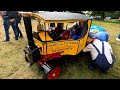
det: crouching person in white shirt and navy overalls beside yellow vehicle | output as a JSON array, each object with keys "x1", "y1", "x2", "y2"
[{"x1": 83, "y1": 37, "x2": 115, "y2": 72}]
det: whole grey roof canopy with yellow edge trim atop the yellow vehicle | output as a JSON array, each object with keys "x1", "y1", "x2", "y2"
[{"x1": 20, "y1": 12, "x2": 91, "y2": 22}]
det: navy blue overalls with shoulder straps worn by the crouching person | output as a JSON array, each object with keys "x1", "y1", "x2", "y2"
[{"x1": 92, "y1": 41, "x2": 115, "y2": 72}]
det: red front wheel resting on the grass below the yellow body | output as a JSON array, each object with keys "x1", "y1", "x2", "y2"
[{"x1": 47, "y1": 67, "x2": 61, "y2": 79}]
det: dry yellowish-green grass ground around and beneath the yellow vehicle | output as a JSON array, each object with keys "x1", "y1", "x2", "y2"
[{"x1": 0, "y1": 18, "x2": 120, "y2": 79}]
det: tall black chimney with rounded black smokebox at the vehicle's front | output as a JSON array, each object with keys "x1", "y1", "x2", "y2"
[{"x1": 23, "y1": 13, "x2": 41, "y2": 65}]
